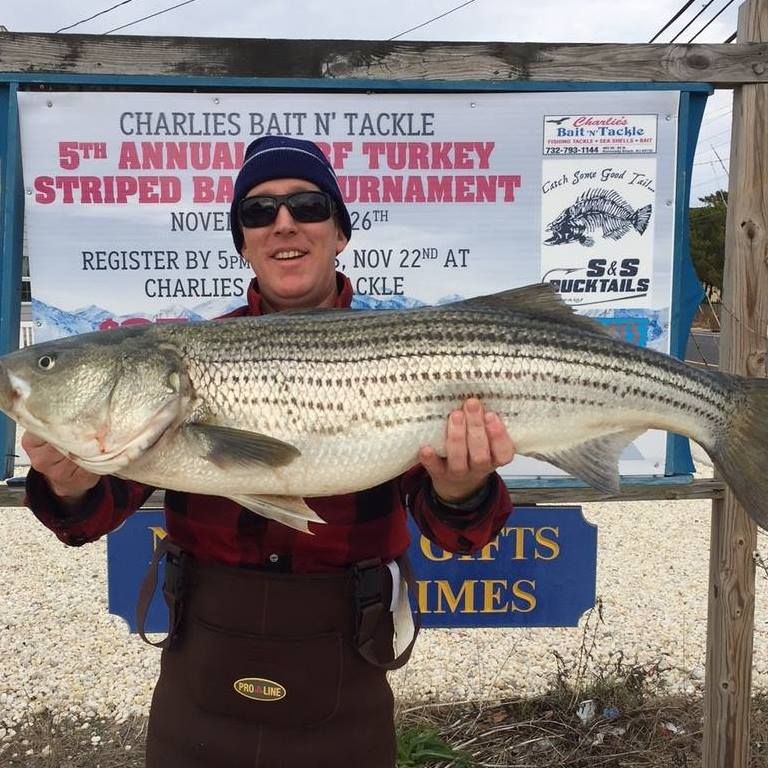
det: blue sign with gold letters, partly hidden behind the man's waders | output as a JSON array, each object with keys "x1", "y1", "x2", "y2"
[{"x1": 107, "y1": 507, "x2": 597, "y2": 632}]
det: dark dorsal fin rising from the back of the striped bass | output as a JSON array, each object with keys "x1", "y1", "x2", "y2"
[{"x1": 456, "y1": 283, "x2": 610, "y2": 336}]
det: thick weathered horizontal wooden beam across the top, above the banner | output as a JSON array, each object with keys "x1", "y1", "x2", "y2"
[{"x1": 0, "y1": 32, "x2": 768, "y2": 88}]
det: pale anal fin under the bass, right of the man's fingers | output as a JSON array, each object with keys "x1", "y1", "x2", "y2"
[{"x1": 528, "y1": 429, "x2": 645, "y2": 494}]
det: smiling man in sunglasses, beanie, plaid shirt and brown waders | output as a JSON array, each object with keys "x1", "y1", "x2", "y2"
[{"x1": 22, "y1": 137, "x2": 514, "y2": 768}]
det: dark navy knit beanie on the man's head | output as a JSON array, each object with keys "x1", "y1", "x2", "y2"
[{"x1": 230, "y1": 136, "x2": 352, "y2": 253}]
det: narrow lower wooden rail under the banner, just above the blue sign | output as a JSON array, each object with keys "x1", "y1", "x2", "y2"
[{"x1": 0, "y1": 480, "x2": 725, "y2": 509}]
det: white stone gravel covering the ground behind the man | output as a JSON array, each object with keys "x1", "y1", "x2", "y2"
[{"x1": 0, "y1": 452, "x2": 768, "y2": 743}]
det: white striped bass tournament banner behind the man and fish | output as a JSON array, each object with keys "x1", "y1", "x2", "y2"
[{"x1": 18, "y1": 91, "x2": 679, "y2": 477}]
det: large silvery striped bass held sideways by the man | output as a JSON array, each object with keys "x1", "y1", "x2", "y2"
[{"x1": 0, "y1": 285, "x2": 768, "y2": 530}]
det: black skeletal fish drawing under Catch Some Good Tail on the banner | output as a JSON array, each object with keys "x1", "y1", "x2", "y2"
[{"x1": 544, "y1": 189, "x2": 653, "y2": 248}]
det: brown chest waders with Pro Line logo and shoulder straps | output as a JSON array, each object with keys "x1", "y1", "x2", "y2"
[{"x1": 137, "y1": 539, "x2": 418, "y2": 768}]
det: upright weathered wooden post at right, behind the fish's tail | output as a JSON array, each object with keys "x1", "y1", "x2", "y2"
[{"x1": 703, "y1": 0, "x2": 768, "y2": 768}]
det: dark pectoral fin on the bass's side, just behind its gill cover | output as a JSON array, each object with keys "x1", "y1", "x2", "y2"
[{"x1": 183, "y1": 424, "x2": 301, "y2": 469}]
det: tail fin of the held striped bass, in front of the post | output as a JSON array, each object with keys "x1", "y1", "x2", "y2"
[{"x1": 704, "y1": 374, "x2": 768, "y2": 530}]
